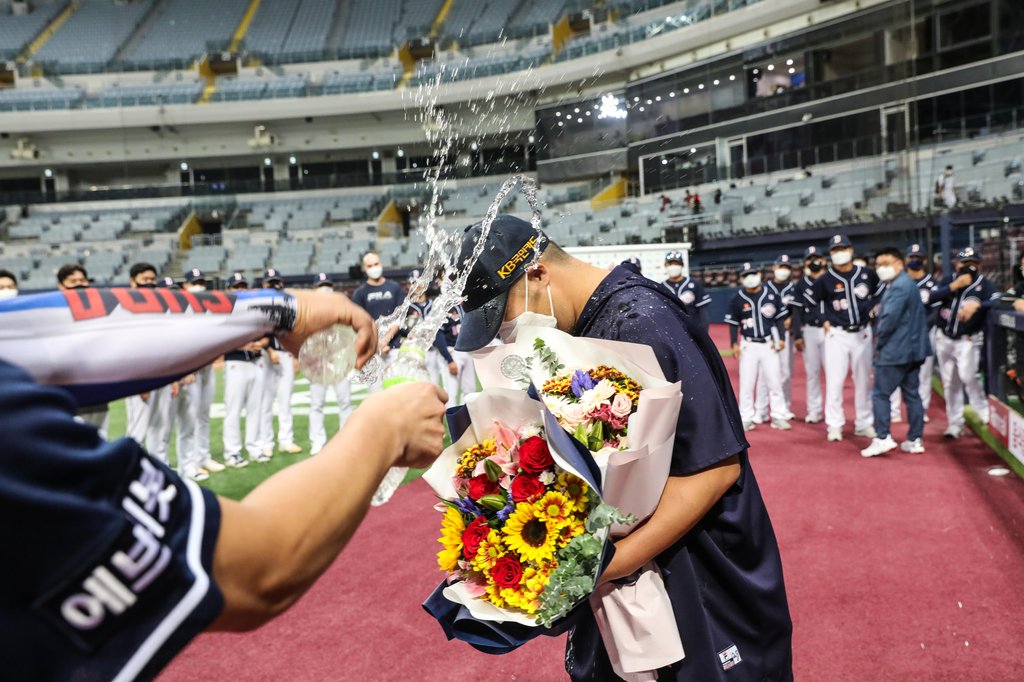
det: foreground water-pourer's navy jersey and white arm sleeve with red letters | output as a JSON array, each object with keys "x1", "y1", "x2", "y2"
[{"x1": 0, "y1": 289, "x2": 295, "y2": 680}]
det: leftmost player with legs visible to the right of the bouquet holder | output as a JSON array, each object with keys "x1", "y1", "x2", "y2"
[{"x1": 725, "y1": 263, "x2": 793, "y2": 431}]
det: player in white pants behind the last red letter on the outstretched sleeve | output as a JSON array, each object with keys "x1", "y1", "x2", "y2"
[{"x1": 224, "y1": 272, "x2": 270, "y2": 469}]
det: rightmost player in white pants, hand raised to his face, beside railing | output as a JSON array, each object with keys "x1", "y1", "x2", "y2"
[{"x1": 929, "y1": 247, "x2": 999, "y2": 438}]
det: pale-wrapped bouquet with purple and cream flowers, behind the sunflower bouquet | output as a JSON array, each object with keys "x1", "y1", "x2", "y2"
[{"x1": 475, "y1": 328, "x2": 692, "y2": 680}]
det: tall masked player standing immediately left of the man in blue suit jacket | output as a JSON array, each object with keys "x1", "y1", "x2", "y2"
[{"x1": 809, "y1": 235, "x2": 882, "y2": 440}]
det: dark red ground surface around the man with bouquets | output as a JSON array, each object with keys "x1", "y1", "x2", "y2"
[{"x1": 162, "y1": 328, "x2": 1024, "y2": 682}]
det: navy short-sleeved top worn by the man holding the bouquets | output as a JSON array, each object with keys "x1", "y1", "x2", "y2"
[{"x1": 566, "y1": 267, "x2": 793, "y2": 682}]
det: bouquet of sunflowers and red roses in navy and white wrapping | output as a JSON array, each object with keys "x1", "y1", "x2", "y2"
[{"x1": 424, "y1": 389, "x2": 632, "y2": 652}]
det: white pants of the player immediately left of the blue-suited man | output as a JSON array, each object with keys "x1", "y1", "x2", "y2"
[{"x1": 824, "y1": 327, "x2": 874, "y2": 431}]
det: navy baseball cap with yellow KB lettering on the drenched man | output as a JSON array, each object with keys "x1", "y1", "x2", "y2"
[{"x1": 455, "y1": 214, "x2": 549, "y2": 351}]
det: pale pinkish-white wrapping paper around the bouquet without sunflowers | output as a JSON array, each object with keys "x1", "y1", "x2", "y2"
[{"x1": 474, "y1": 328, "x2": 684, "y2": 671}]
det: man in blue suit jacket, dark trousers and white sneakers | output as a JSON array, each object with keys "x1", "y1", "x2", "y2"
[{"x1": 860, "y1": 249, "x2": 932, "y2": 457}]
